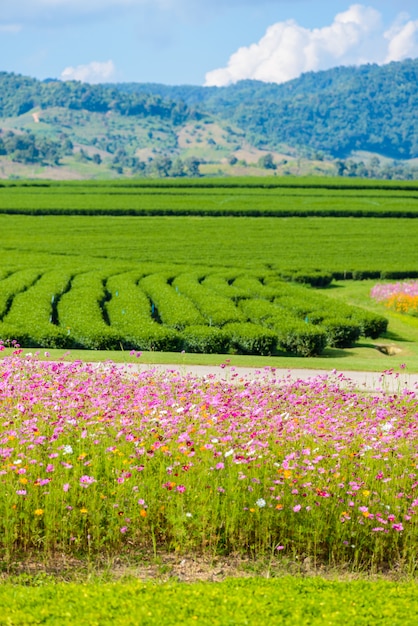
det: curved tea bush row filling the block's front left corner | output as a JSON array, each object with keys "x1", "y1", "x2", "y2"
[{"x1": 0, "y1": 271, "x2": 71, "y2": 348}]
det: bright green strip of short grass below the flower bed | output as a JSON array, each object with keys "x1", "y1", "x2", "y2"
[{"x1": 0, "y1": 577, "x2": 418, "y2": 626}]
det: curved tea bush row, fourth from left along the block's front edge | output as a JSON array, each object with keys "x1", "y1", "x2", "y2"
[{"x1": 139, "y1": 274, "x2": 205, "y2": 331}]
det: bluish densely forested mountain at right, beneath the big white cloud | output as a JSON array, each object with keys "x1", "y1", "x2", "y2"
[{"x1": 110, "y1": 59, "x2": 418, "y2": 159}]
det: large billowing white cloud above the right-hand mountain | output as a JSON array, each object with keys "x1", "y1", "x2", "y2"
[{"x1": 205, "y1": 4, "x2": 418, "y2": 86}]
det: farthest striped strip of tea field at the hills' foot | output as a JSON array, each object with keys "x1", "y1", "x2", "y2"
[{"x1": 0, "y1": 177, "x2": 418, "y2": 218}]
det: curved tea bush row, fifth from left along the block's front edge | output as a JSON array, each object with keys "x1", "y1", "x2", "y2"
[{"x1": 173, "y1": 274, "x2": 246, "y2": 326}]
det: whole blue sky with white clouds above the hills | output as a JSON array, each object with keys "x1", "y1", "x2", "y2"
[{"x1": 0, "y1": 0, "x2": 418, "y2": 85}]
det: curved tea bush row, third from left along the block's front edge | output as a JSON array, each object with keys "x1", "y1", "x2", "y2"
[{"x1": 105, "y1": 272, "x2": 180, "y2": 352}]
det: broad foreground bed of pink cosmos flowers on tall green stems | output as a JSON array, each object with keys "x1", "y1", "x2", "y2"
[{"x1": 0, "y1": 349, "x2": 418, "y2": 571}]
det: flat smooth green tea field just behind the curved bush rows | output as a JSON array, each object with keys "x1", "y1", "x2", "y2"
[{"x1": 0, "y1": 215, "x2": 418, "y2": 285}]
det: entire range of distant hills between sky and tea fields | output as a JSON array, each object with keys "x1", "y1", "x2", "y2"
[{"x1": 0, "y1": 59, "x2": 418, "y2": 178}]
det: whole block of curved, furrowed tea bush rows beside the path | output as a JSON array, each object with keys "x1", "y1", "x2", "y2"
[{"x1": 0, "y1": 266, "x2": 387, "y2": 356}]
